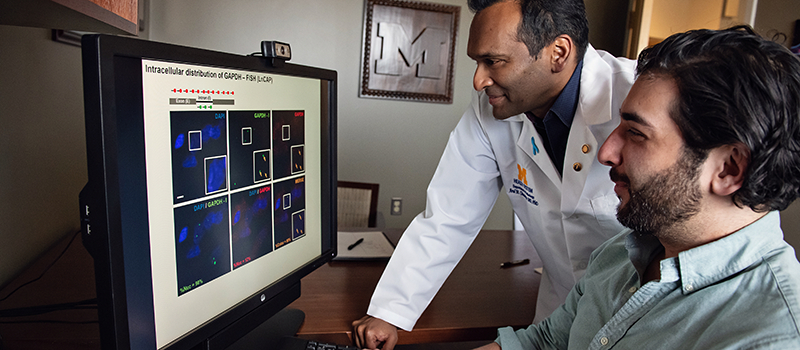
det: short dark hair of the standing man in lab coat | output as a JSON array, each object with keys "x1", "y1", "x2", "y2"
[{"x1": 467, "y1": 0, "x2": 589, "y2": 61}]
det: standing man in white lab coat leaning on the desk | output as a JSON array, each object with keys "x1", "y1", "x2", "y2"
[{"x1": 353, "y1": 0, "x2": 635, "y2": 350}]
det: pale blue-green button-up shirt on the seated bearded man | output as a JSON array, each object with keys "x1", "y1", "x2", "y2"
[{"x1": 496, "y1": 212, "x2": 800, "y2": 350}]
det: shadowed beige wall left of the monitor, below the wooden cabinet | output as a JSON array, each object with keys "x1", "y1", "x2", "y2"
[{"x1": 0, "y1": 25, "x2": 87, "y2": 286}]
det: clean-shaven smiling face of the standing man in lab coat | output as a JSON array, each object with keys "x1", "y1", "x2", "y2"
[{"x1": 467, "y1": 1, "x2": 563, "y2": 119}]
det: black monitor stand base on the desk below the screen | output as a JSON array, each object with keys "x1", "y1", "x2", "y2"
[{"x1": 228, "y1": 308, "x2": 306, "y2": 350}]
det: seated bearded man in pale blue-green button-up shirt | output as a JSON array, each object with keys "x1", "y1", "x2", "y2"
[{"x1": 485, "y1": 27, "x2": 800, "y2": 350}]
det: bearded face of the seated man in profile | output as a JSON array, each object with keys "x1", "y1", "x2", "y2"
[{"x1": 598, "y1": 75, "x2": 704, "y2": 235}]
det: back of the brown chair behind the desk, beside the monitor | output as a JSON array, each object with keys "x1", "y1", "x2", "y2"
[{"x1": 337, "y1": 181, "x2": 380, "y2": 228}]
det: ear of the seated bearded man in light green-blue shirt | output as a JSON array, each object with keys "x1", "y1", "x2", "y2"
[{"x1": 709, "y1": 143, "x2": 750, "y2": 196}]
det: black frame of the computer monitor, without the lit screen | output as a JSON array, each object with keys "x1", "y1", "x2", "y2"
[{"x1": 80, "y1": 35, "x2": 337, "y2": 350}]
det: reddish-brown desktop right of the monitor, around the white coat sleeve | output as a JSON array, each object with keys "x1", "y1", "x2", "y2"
[{"x1": 289, "y1": 230, "x2": 542, "y2": 344}]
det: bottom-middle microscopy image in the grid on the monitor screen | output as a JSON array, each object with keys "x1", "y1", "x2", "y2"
[{"x1": 231, "y1": 186, "x2": 273, "y2": 269}]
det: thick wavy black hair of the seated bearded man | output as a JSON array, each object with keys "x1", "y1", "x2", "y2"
[{"x1": 637, "y1": 26, "x2": 800, "y2": 212}]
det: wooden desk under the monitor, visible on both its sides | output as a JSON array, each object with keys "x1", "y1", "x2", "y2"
[{"x1": 0, "y1": 230, "x2": 541, "y2": 350}]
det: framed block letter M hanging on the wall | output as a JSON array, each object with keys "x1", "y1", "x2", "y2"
[{"x1": 358, "y1": 0, "x2": 461, "y2": 104}]
